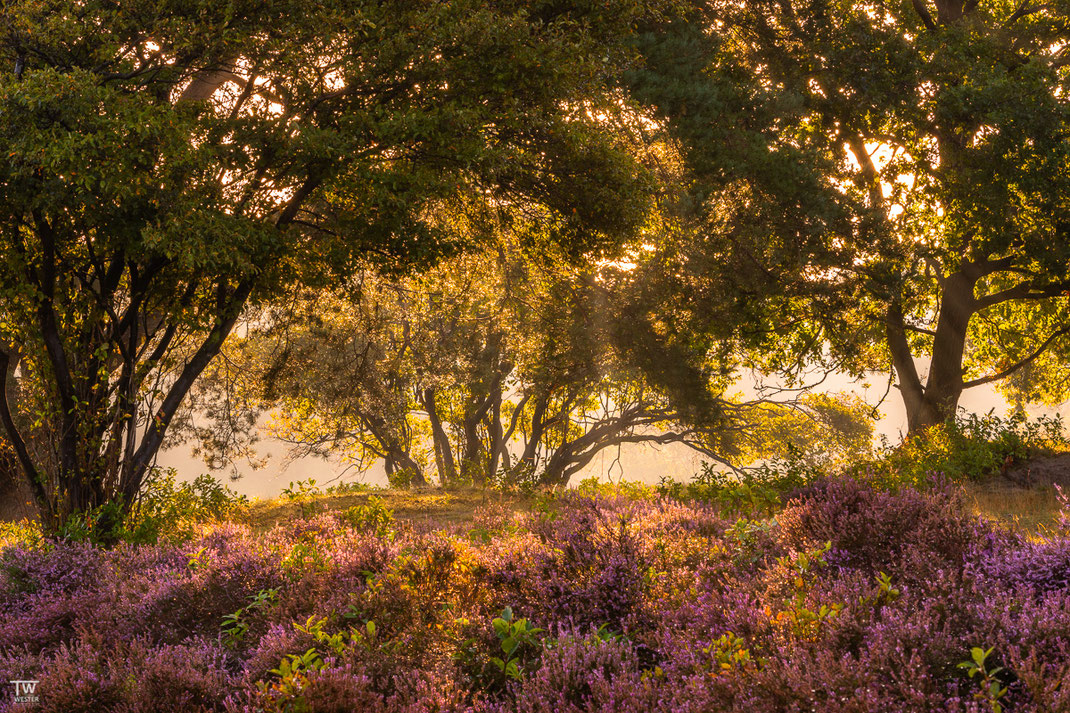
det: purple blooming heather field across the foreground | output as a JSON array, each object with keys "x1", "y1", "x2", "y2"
[{"x1": 0, "y1": 480, "x2": 1070, "y2": 713}]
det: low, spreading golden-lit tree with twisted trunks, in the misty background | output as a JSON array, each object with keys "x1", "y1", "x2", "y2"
[{"x1": 212, "y1": 244, "x2": 872, "y2": 486}]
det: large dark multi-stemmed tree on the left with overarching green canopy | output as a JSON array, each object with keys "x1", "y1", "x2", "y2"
[{"x1": 0, "y1": 0, "x2": 642, "y2": 528}]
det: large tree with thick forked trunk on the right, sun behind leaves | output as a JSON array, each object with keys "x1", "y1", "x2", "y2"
[{"x1": 631, "y1": 0, "x2": 1070, "y2": 430}]
